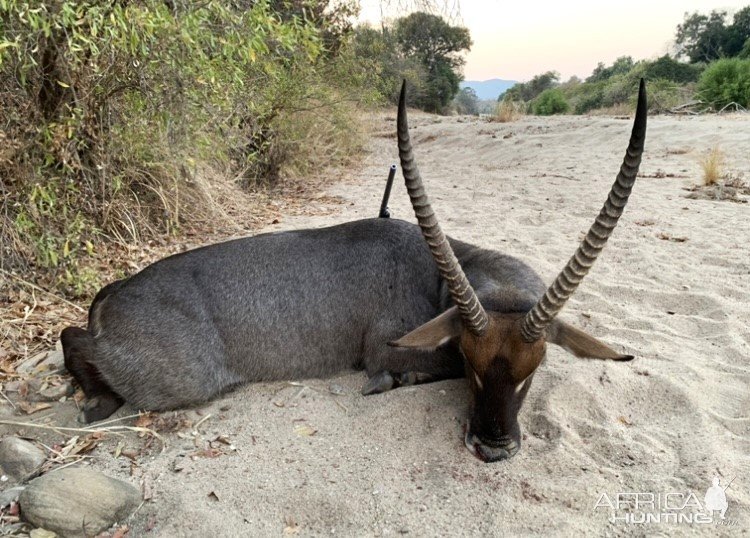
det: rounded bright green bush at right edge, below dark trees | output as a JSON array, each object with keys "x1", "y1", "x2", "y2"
[{"x1": 698, "y1": 58, "x2": 750, "y2": 110}]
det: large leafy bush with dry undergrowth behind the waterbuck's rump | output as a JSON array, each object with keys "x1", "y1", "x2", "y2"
[{"x1": 0, "y1": 0, "x2": 378, "y2": 293}]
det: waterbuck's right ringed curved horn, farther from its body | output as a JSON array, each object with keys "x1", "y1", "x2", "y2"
[{"x1": 521, "y1": 79, "x2": 648, "y2": 342}]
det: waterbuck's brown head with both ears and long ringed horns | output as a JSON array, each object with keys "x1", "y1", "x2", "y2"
[{"x1": 391, "y1": 80, "x2": 647, "y2": 462}]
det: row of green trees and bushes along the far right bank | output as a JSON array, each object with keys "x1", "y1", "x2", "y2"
[{"x1": 498, "y1": 6, "x2": 750, "y2": 114}]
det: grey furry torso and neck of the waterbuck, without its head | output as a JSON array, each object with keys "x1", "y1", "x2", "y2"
[{"x1": 69, "y1": 219, "x2": 545, "y2": 410}]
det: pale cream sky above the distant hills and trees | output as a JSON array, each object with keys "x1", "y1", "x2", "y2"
[{"x1": 360, "y1": 0, "x2": 750, "y2": 81}]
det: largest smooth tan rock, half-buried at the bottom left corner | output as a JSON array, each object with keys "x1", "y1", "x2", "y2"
[{"x1": 19, "y1": 467, "x2": 141, "y2": 536}]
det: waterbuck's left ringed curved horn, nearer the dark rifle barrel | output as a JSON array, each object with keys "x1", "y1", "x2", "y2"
[{"x1": 397, "y1": 81, "x2": 488, "y2": 336}]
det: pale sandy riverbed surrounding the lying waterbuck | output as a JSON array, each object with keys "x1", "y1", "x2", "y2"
[{"x1": 1, "y1": 109, "x2": 750, "y2": 537}]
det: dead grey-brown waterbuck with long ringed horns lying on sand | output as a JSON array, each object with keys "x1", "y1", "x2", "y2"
[{"x1": 61, "y1": 82, "x2": 646, "y2": 461}]
